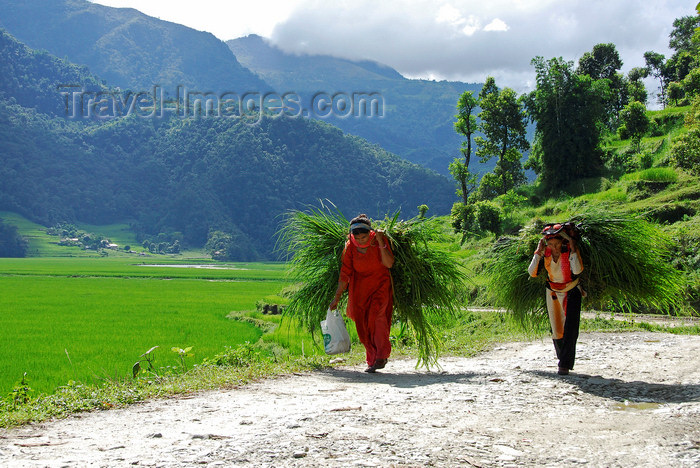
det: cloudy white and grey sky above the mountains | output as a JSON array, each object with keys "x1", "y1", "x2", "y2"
[{"x1": 95, "y1": 0, "x2": 697, "y2": 92}]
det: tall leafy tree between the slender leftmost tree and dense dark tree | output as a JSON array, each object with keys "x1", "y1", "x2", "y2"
[{"x1": 474, "y1": 76, "x2": 530, "y2": 198}]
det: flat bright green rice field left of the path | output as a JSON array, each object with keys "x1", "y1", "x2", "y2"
[{"x1": 0, "y1": 258, "x2": 288, "y2": 398}]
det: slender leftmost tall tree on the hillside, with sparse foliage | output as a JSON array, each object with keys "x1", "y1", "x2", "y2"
[{"x1": 449, "y1": 91, "x2": 479, "y2": 205}]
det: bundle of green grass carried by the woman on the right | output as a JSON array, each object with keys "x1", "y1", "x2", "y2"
[{"x1": 486, "y1": 209, "x2": 685, "y2": 325}]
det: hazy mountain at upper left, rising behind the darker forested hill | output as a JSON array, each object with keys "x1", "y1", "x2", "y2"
[{"x1": 0, "y1": 0, "x2": 268, "y2": 95}]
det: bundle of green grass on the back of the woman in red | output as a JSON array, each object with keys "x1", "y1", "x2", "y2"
[{"x1": 280, "y1": 205, "x2": 466, "y2": 368}]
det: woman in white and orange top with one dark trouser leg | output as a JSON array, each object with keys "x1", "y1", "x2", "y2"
[{"x1": 528, "y1": 224, "x2": 583, "y2": 375}]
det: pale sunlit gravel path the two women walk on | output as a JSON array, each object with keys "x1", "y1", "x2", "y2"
[{"x1": 0, "y1": 333, "x2": 700, "y2": 467}]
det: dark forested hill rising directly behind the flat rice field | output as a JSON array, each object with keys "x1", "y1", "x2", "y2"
[{"x1": 0, "y1": 34, "x2": 454, "y2": 259}]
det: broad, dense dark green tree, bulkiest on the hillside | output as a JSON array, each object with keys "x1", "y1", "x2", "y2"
[{"x1": 526, "y1": 57, "x2": 603, "y2": 193}]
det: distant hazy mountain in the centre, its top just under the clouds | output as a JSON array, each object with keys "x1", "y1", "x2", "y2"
[{"x1": 226, "y1": 35, "x2": 481, "y2": 174}]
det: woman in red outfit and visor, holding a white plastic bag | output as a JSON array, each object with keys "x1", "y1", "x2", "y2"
[{"x1": 329, "y1": 214, "x2": 394, "y2": 373}]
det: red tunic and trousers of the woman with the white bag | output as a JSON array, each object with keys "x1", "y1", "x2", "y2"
[{"x1": 340, "y1": 240, "x2": 394, "y2": 366}]
